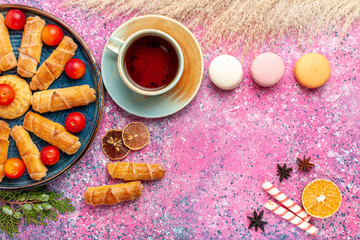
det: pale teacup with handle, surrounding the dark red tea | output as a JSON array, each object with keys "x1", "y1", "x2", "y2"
[{"x1": 106, "y1": 29, "x2": 184, "y2": 96}]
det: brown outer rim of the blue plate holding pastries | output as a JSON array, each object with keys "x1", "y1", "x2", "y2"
[{"x1": 0, "y1": 4, "x2": 104, "y2": 191}]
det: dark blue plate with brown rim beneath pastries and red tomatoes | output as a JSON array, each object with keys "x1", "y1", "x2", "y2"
[{"x1": 0, "y1": 5, "x2": 103, "y2": 190}]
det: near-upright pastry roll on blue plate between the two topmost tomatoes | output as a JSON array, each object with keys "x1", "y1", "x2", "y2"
[{"x1": 17, "y1": 16, "x2": 45, "y2": 78}]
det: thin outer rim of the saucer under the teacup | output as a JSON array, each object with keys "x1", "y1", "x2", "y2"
[{"x1": 100, "y1": 14, "x2": 205, "y2": 119}]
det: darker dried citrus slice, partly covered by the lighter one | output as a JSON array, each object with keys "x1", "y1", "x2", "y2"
[{"x1": 101, "y1": 129, "x2": 130, "y2": 161}]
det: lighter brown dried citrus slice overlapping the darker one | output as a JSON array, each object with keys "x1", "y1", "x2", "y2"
[{"x1": 122, "y1": 122, "x2": 150, "y2": 150}]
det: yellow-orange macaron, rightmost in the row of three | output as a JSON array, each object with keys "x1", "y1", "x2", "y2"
[{"x1": 294, "y1": 53, "x2": 331, "y2": 88}]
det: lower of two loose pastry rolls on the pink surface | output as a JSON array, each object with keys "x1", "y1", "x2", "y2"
[{"x1": 84, "y1": 181, "x2": 143, "y2": 206}]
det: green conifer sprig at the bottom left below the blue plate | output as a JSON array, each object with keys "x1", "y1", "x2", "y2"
[{"x1": 0, "y1": 187, "x2": 75, "y2": 237}]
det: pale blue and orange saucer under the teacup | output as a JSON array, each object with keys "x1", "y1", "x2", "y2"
[{"x1": 101, "y1": 15, "x2": 204, "y2": 118}]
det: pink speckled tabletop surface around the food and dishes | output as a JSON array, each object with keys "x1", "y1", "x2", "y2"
[{"x1": 0, "y1": 0, "x2": 360, "y2": 239}]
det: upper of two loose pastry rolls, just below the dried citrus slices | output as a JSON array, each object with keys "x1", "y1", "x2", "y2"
[{"x1": 106, "y1": 162, "x2": 165, "y2": 181}]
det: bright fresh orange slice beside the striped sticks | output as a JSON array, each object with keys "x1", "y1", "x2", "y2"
[{"x1": 301, "y1": 179, "x2": 341, "y2": 218}]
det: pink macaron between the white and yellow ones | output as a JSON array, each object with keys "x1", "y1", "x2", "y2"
[{"x1": 250, "y1": 52, "x2": 285, "y2": 87}]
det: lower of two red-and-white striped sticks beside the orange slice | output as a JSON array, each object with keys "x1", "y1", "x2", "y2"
[{"x1": 265, "y1": 200, "x2": 319, "y2": 236}]
